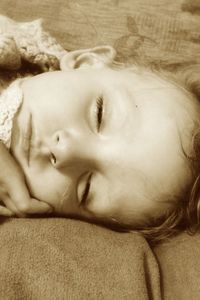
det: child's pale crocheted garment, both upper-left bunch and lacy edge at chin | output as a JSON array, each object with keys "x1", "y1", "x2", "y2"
[{"x1": 0, "y1": 15, "x2": 67, "y2": 148}]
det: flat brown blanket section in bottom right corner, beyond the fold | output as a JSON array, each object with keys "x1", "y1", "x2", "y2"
[{"x1": 154, "y1": 233, "x2": 200, "y2": 300}]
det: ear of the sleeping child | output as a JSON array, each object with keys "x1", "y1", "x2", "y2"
[{"x1": 60, "y1": 46, "x2": 116, "y2": 71}]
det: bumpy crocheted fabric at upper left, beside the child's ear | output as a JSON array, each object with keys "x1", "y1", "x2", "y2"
[{"x1": 0, "y1": 15, "x2": 67, "y2": 71}]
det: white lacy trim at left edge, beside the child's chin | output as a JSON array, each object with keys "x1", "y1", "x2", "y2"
[{"x1": 0, "y1": 79, "x2": 23, "y2": 149}]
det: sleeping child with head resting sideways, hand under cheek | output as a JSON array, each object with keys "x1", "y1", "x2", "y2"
[{"x1": 0, "y1": 15, "x2": 200, "y2": 239}]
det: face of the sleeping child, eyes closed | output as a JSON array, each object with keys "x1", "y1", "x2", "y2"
[{"x1": 11, "y1": 68, "x2": 197, "y2": 223}]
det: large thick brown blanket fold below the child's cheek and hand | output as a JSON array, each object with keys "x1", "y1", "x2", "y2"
[{"x1": 0, "y1": 218, "x2": 161, "y2": 300}]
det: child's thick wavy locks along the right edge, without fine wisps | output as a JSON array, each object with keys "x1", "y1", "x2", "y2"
[{"x1": 140, "y1": 64, "x2": 200, "y2": 242}]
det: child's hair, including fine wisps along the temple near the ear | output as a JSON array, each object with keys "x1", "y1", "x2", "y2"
[{"x1": 110, "y1": 61, "x2": 200, "y2": 243}]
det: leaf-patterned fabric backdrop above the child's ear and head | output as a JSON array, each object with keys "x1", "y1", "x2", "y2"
[{"x1": 0, "y1": 0, "x2": 200, "y2": 66}]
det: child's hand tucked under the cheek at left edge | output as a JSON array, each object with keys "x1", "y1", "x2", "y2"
[{"x1": 0, "y1": 142, "x2": 52, "y2": 217}]
